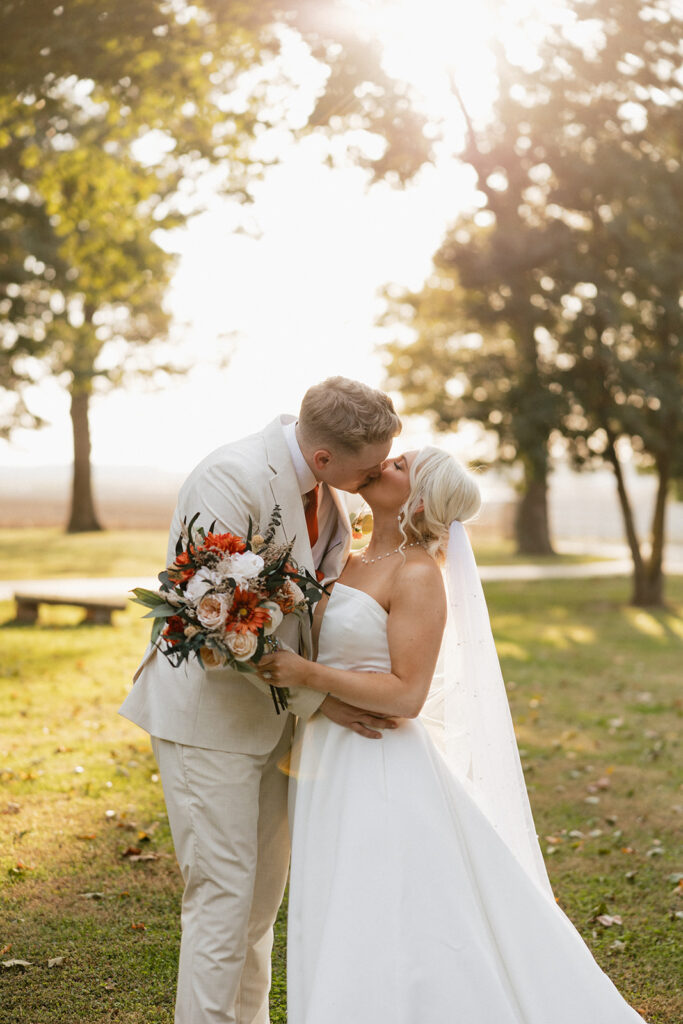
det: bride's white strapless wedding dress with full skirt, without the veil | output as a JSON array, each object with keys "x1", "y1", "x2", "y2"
[{"x1": 288, "y1": 583, "x2": 643, "y2": 1024}]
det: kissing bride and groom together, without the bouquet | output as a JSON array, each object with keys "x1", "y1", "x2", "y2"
[{"x1": 121, "y1": 377, "x2": 642, "y2": 1024}]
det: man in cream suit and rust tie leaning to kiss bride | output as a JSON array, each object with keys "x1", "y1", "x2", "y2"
[{"x1": 121, "y1": 377, "x2": 400, "y2": 1024}]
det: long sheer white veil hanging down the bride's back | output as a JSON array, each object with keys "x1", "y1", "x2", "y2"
[{"x1": 420, "y1": 521, "x2": 554, "y2": 900}]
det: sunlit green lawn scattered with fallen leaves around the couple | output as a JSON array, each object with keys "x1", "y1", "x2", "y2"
[{"x1": 0, "y1": 577, "x2": 683, "y2": 1024}]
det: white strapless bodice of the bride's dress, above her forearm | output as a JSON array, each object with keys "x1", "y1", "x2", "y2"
[{"x1": 317, "y1": 583, "x2": 391, "y2": 672}]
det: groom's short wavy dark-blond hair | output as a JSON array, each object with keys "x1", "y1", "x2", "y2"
[{"x1": 299, "y1": 377, "x2": 400, "y2": 453}]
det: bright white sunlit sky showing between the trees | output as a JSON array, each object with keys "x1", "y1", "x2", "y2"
[{"x1": 0, "y1": 0, "x2": 577, "y2": 469}]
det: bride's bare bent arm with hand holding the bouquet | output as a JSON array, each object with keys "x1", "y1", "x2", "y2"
[{"x1": 259, "y1": 562, "x2": 446, "y2": 718}]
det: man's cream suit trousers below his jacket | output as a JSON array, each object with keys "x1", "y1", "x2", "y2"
[{"x1": 152, "y1": 716, "x2": 293, "y2": 1024}]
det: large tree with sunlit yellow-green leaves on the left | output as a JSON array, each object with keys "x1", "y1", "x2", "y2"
[{"x1": 0, "y1": 0, "x2": 429, "y2": 530}]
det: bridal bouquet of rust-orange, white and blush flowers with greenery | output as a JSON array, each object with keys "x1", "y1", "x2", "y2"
[{"x1": 133, "y1": 505, "x2": 323, "y2": 714}]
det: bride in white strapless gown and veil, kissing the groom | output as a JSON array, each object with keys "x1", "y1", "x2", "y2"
[{"x1": 261, "y1": 447, "x2": 643, "y2": 1024}]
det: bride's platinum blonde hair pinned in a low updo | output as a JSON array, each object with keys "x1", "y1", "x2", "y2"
[{"x1": 399, "y1": 444, "x2": 481, "y2": 564}]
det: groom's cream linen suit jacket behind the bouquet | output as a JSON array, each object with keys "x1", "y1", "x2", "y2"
[{"x1": 119, "y1": 416, "x2": 351, "y2": 754}]
